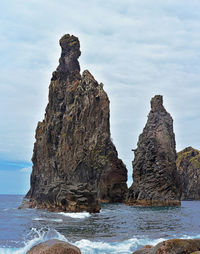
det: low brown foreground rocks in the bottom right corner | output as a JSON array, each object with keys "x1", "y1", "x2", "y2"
[{"x1": 133, "y1": 239, "x2": 200, "y2": 254}]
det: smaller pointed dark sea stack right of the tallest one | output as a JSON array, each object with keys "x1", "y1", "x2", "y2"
[{"x1": 126, "y1": 95, "x2": 181, "y2": 206}]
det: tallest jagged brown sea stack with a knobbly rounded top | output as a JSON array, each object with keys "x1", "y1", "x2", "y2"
[{"x1": 23, "y1": 35, "x2": 127, "y2": 212}]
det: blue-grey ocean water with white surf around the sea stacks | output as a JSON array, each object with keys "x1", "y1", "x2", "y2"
[{"x1": 0, "y1": 195, "x2": 200, "y2": 254}]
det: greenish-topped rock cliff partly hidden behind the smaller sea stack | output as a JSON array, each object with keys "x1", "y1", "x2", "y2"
[{"x1": 176, "y1": 147, "x2": 200, "y2": 200}]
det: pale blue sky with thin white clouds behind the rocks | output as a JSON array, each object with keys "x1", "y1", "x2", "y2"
[{"x1": 0, "y1": 0, "x2": 200, "y2": 194}]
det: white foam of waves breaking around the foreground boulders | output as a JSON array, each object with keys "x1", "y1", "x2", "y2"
[{"x1": 0, "y1": 228, "x2": 200, "y2": 254}]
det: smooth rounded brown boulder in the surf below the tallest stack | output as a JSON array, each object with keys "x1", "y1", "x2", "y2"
[{"x1": 27, "y1": 239, "x2": 81, "y2": 254}]
